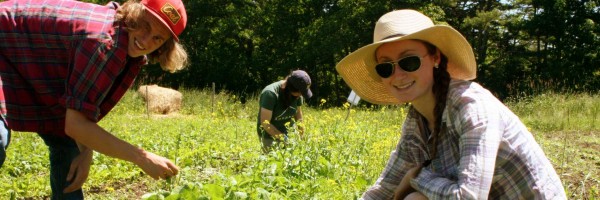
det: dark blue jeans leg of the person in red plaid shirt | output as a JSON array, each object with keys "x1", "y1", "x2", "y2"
[{"x1": 38, "y1": 134, "x2": 83, "y2": 200}]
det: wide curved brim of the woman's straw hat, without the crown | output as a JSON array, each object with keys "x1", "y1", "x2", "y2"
[{"x1": 336, "y1": 25, "x2": 477, "y2": 105}]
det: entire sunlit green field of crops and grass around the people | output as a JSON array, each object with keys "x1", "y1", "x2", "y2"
[{"x1": 0, "y1": 90, "x2": 600, "y2": 199}]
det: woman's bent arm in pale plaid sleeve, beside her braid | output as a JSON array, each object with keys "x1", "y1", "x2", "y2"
[{"x1": 411, "y1": 88, "x2": 503, "y2": 199}]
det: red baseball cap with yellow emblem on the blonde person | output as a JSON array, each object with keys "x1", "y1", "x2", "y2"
[{"x1": 140, "y1": 0, "x2": 187, "y2": 42}]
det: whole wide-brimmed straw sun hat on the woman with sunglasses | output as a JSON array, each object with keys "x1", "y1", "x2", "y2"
[{"x1": 336, "y1": 10, "x2": 476, "y2": 104}]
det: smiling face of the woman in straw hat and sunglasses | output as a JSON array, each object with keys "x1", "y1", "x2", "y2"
[{"x1": 375, "y1": 40, "x2": 439, "y2": 103}]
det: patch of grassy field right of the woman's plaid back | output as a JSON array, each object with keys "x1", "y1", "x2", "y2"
[{"x1": 507, "y1": 92, "x2": 600, "y2": 199}]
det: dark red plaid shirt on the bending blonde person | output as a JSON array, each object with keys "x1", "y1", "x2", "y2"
[{"x1": 0, "y1": 0, "x2": 146, "y2": 135}]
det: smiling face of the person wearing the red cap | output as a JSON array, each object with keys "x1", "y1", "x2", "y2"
[{"x1": 127, "y1": 13, "x2": 171, "y2": 58}]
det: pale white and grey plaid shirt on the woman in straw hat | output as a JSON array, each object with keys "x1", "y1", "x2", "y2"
[{"x1": 363, "y1": 80, "x2": 566, "y2": 199}]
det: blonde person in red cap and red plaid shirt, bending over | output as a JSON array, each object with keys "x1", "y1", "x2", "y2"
[{"x1": 0, "y1": 0, "x2": 187, "y2": 199}]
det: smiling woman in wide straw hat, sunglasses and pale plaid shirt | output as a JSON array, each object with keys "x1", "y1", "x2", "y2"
[{"x1": 336, "y1": 10, "x2": 566, "y2": 199}]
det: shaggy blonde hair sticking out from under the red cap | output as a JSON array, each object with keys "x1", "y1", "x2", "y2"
[{"x1": 115, "y1": 0, "x2": 188, "y2": 72}]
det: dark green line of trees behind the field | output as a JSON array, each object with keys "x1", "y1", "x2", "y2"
[{"x1": 90, "y1": 0, "x2": 600, "y2": 105}]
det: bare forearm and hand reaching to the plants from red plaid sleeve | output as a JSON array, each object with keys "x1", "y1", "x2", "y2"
[{"x1": 65, "y1": 109, "x2": 179, "y2": 179}]
